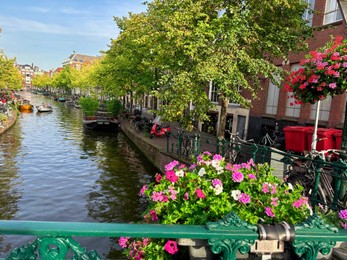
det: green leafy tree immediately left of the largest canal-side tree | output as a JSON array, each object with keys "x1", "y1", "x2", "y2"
[{"x1": 96, "y1": 13, "x2": 155, "y2": 109}]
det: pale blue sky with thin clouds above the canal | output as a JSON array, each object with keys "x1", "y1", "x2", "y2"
[{"x1": 0, "y1": 0, "x2": 146, "y2": 70}]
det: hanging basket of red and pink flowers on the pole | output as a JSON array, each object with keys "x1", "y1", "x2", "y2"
[{"x1": 285, "y1": 36, "x2": 347, "y2": 104}]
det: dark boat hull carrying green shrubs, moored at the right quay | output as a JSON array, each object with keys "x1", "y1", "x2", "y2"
[{"x1": 82, "y1": 111, "x2": 120, "y2": 131}]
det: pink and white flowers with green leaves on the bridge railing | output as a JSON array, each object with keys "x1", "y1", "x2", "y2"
[{"x1": 119, "y1": 152, "x2": 311, "y2": 259}]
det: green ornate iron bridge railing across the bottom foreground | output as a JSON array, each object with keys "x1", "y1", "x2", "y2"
[{"x1": 0, "y1": 213, "x2": 347, "y2": 260}]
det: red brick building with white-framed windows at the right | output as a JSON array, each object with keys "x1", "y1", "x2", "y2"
[{"x1": 248, "y1": 0, "x2": 347, "y2": 140}]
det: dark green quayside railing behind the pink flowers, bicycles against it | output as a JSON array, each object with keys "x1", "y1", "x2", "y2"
[{"x1": 167, "y1": 131, "x2": 347, "y2": 210}]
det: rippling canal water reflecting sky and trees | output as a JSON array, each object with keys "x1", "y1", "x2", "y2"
[{"x1": 0, "y1": 93, "x2": 157, "y2": 259}]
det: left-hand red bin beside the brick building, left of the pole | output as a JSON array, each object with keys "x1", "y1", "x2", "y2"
[{"x1": 283, "y1": 126, "x2": 307, "y2": 153}]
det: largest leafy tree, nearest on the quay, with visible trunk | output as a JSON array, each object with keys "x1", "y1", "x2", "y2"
[{"x1": 141, "y1": 0, "x2": 311, "y2": 136}]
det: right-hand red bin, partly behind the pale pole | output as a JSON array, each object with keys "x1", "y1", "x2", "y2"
[{"x1": 306, "y1": 128, "x2": 336, "y2": 151}]
